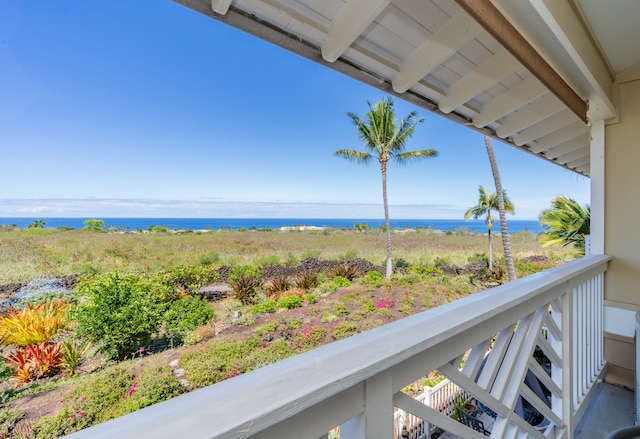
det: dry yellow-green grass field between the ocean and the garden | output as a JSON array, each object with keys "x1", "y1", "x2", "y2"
[{"x1": 0, "y1": 229, "x2": 574, "y2": 284}]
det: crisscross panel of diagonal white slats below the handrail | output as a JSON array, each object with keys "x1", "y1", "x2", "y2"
[{"x1": 394, "y1": 299, "x2": 564, "y2": 438}]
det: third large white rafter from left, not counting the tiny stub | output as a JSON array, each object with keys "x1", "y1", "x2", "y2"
[{"x1": 438, "y1": 49, "x2": 519, "y2": 113}]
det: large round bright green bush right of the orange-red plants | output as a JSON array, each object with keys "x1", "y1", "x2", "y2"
[{"x1": 72, "y1": 272, "x2": 167, "y2": 360}]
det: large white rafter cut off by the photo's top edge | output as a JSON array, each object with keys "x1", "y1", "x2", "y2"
[{"x1": 321, "y1": 0, "x2": 390, "y2": 62}]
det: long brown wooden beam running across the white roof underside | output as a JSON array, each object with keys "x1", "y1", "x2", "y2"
[{"x1": 456, "y1": 0, "x2": 587, "y2": 123}]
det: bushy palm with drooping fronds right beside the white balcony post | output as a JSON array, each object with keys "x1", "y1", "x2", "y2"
[{"x1": 538, "y1": 195, "x2": 591, "y2": 256}]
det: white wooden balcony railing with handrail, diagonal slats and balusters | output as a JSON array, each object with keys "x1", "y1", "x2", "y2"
[{"x1": 65, "y1": 256, "x2": 610, "y2": 439}]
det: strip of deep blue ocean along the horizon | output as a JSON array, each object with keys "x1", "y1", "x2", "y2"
[{"x1": 0, "y1": 217, "x2": 543, "y2": 234}]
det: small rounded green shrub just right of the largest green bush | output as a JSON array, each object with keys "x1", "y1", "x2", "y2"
[{"x1": 161, "y1": 296, "x2": 215, "y2": 337}]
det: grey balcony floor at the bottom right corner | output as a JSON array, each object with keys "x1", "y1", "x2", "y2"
[{"x1": 573, "y1": 383, "x2": 635, "y2": 439}]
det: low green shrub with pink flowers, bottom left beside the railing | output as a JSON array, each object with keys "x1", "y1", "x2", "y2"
[{"x1": 33, "y1": 366, "x2": 185, "y2": 438}]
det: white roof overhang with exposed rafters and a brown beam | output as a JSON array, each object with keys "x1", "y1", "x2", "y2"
[{"x1": 174, "y1": 0, "x2": 613, "y2": 176}]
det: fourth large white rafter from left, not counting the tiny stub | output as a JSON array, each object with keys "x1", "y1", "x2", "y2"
[{"x1": 473, "y1": 76, "x2": 546, "y2": 128}]
